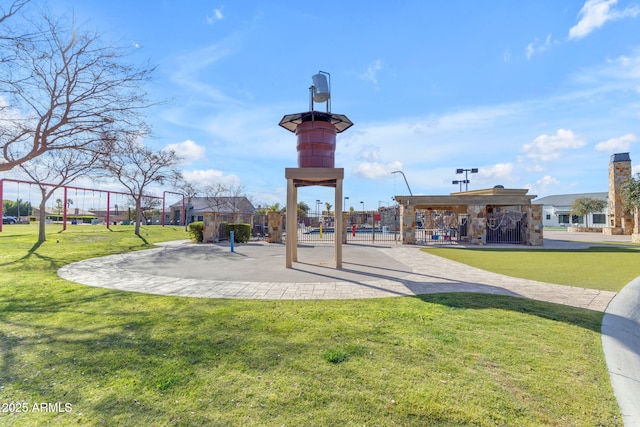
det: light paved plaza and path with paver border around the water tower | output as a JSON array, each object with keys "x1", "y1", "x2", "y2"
[{"x1": 58, "y1": 237, "x2": 615, "y2": 311}]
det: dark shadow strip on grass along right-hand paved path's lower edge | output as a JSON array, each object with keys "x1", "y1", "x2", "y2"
[{"x1": 414, "y1": 293, "x2": 604, "y2": 333}]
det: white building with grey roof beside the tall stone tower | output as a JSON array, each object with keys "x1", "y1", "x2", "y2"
[{"x1": 531, "y1": 191, "x2": 609, "y2": 227}]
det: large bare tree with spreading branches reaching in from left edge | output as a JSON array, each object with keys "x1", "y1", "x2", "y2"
[{"x1": 0, "y1": 10, "x2": 153, "y2": 171}]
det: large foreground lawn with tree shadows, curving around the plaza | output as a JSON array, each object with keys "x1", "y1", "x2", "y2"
[{"x1": 0, "y1": 226, "x2": 622, "y2": 426}]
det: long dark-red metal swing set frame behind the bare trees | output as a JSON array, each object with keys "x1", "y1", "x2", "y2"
[{"x1": 0, "y1": 178, "x2": 185, "y2": 233}]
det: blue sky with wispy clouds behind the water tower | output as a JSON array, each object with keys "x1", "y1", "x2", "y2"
[{"x1": 3, "y1": 0, "x2": 640, "y2": 209}]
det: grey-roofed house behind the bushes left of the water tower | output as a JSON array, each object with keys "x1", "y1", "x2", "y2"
[{"x1": 165, "y1": 197, "x2": 256, "y2": 224}]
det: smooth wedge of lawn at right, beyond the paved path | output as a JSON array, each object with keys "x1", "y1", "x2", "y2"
[{"x1": 422, "y1": 245, "x2": 640, "y2": 292}]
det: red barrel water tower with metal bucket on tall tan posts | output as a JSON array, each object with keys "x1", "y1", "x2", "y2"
[{"x1": 279, "y1": 72, "x2": 353, "y2": 268}]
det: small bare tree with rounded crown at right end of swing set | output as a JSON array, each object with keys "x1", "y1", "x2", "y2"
[{"x1": 100, "y1": 139, "x2": 181, "y2": 236}]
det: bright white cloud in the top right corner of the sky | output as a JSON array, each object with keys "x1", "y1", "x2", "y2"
[{"x1": 569, "y1": 0, "x2": 640, "y2": 39}]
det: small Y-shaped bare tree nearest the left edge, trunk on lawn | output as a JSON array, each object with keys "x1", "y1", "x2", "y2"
[{"x1": 19, "y1": 146, "x2": 100, "y2": 242}]
